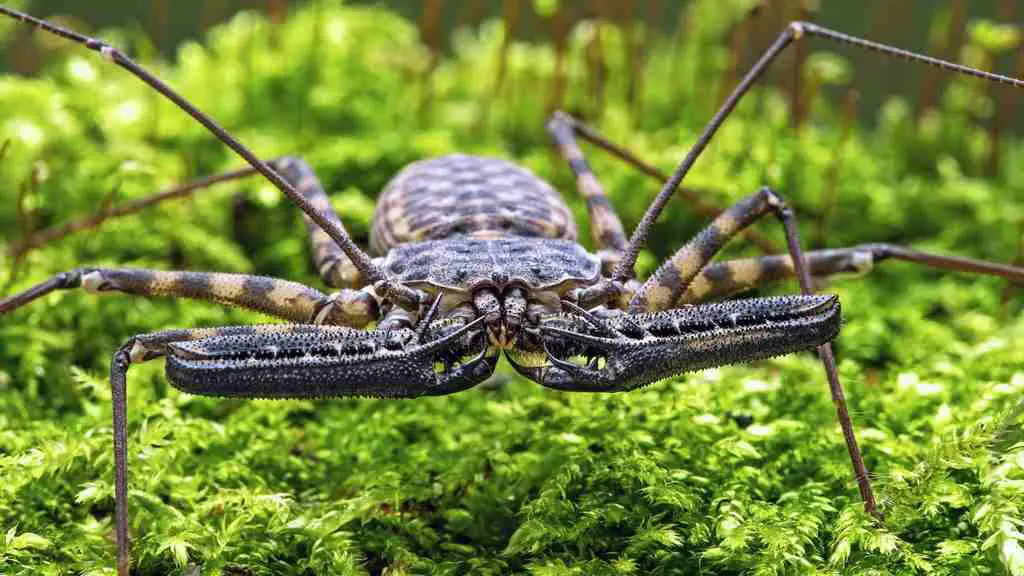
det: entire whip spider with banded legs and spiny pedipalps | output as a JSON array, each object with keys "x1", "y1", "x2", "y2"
[{"x1": 0, "y1": 6, "x2": 1024, "y2": 576}]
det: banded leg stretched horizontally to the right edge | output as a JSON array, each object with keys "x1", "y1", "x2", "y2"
[{"x1": 674, "y1": 244, "x2": 1024, "y2": 307}]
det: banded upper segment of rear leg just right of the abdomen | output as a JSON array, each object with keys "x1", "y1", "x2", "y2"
[{"x1": 548, "y1": 112, "x2": 627, "y2": 271}]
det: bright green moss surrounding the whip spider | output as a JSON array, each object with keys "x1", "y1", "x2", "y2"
[{"x1": 0, "y1": 0, "x2": 1024, "y2": 575}]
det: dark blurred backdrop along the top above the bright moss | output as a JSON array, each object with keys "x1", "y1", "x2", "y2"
[{"x1": 4, "y1": 0, "x2": 1024, "y2": 130}]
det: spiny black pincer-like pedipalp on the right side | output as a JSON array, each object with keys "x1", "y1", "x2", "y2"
[{"x1": 513, "y1": 295, "x2": 840, "y2": 392}]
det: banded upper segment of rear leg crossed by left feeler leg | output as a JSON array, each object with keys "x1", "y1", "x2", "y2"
[{"x1": 271, "y1": 157, "x2": 366, "y2": 289}]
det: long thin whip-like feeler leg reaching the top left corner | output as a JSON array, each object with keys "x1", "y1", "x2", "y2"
[{"x1": 0, "y1": 6, "x2": 426, "y2": 310}]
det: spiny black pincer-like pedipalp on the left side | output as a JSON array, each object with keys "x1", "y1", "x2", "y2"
[{"x1": 166, "y1": 315, "x2": 495, "y2": 398}]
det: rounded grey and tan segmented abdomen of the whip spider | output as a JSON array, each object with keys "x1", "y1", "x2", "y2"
[{"x1": 370, "y1": 155, "x2": 577, "y2": 254}]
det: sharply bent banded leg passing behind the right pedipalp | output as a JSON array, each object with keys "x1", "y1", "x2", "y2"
[{"x1": 629, "y1": 187, "x2": 878, "y2": 515}]
